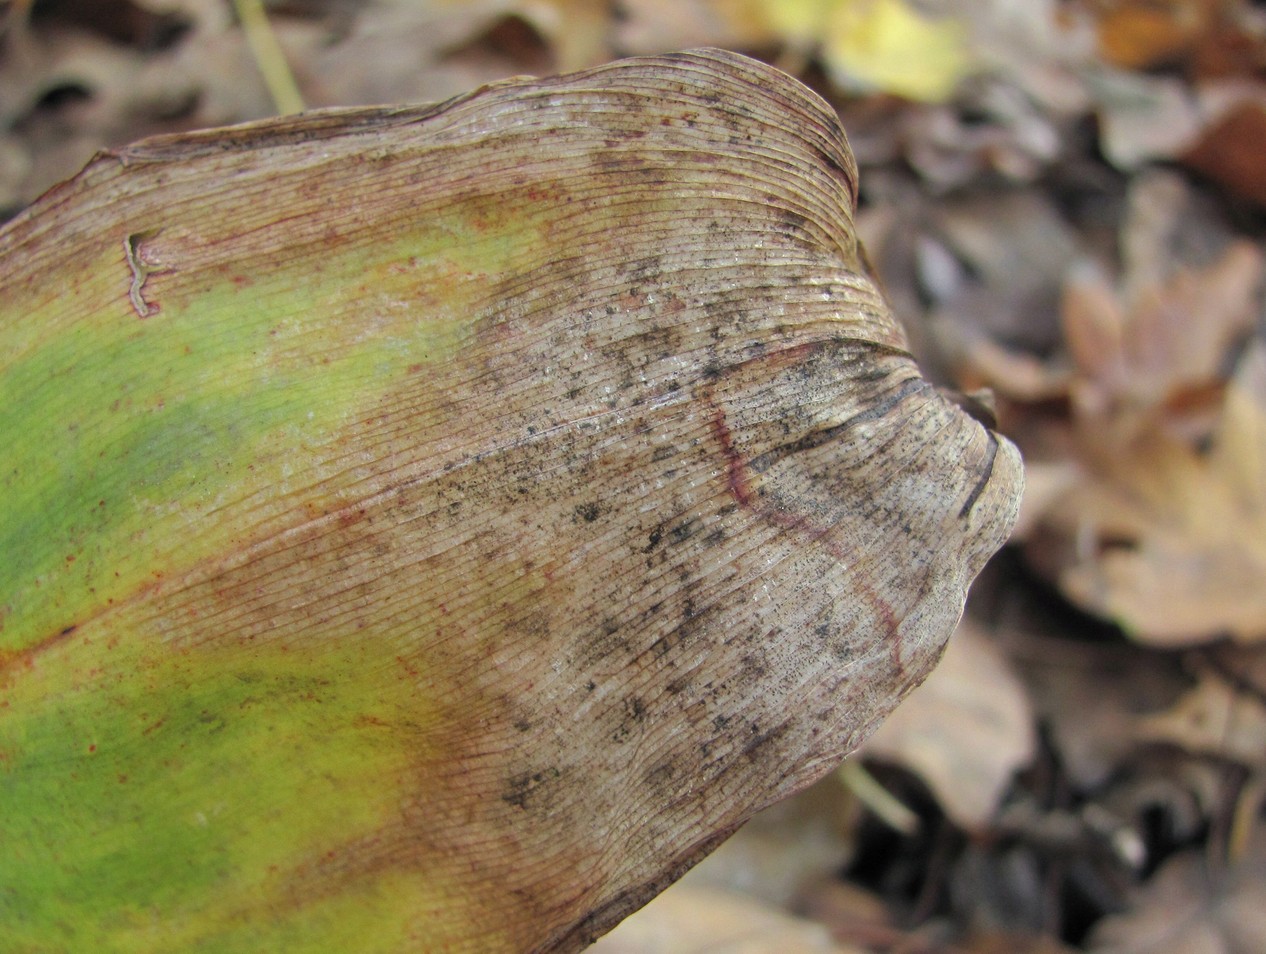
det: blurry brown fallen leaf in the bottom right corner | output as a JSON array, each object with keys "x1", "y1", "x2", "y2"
[{"x1": 1087, "y1": 830, "x2": 1266, "y2": 954}]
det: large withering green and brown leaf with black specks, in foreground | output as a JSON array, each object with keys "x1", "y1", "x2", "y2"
[{"x1": 0, "y1": 52, "x2": 1020, "y2": 951}]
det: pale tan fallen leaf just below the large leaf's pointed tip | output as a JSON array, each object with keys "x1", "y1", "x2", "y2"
[{"x1": 861, "y1": 621, "x2": 1036, "y2": 830}]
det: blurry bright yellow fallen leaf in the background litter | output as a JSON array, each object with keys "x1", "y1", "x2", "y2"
[{"x1": 765, "y1": 0, "x2": 971, "y2": 101}]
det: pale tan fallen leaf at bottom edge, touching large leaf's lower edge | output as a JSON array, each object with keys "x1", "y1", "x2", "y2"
[{"x1": 589, "y1": 884, "x2": 865, "y2": 954}]
